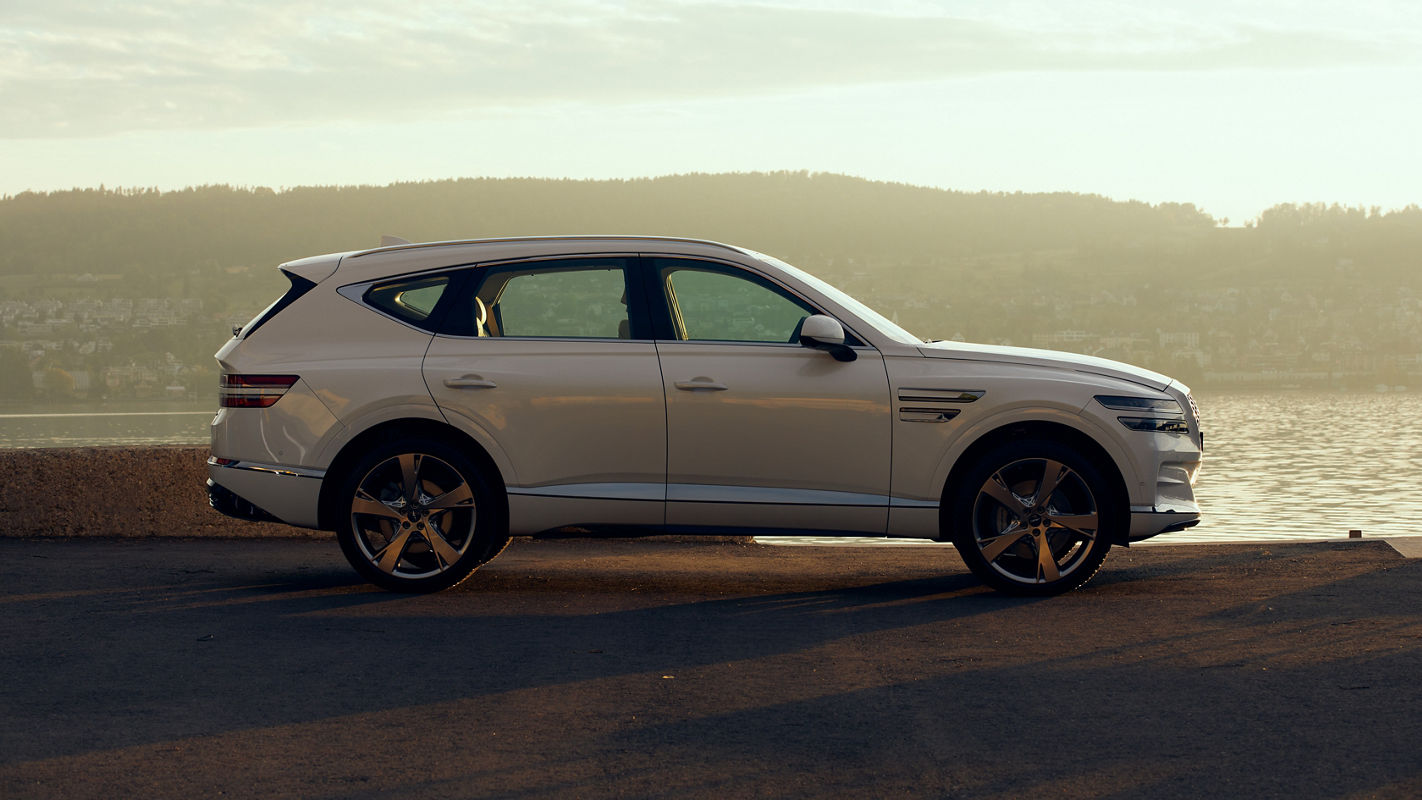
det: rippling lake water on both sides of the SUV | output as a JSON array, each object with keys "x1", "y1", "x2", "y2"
[{"x1": 0, "y1": 392, "x2": 1422, "y2": 541}]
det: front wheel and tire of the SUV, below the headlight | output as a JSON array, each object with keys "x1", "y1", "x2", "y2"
[{"x1": 947, "y1": 439, "x2": 1128, "y2": 597}]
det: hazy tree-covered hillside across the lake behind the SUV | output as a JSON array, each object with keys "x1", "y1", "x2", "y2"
[{"x1": 0, "y1": 172, "x2": 1422, "y2": 400}]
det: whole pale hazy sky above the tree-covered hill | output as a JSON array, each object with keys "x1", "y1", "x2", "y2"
[{"x1": 0, "y1": 0, "x2": 1422, "y2": 223}]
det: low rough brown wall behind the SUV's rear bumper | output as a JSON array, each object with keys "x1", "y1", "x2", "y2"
[{"x1": 0, "y1": 446, "x2": 317, "y2": 537}]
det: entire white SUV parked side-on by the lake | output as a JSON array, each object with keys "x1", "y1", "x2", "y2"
[{"x1": 208, "y1": 236, "x2": 1203, "y2": 594}]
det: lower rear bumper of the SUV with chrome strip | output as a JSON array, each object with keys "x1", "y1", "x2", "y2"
[{"x1": 208, "y1": 458, "x2": 326, "y2": 527}]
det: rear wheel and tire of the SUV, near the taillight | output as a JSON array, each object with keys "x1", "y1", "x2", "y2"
[{"x1": 336, "y1": 438, "x2": 509, "y2": 593}]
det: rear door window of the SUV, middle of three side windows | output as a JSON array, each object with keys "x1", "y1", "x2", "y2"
[{"x1": 447, "y1": 259, "x2": 631, "y2": 338}]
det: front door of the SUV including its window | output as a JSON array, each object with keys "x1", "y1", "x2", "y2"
[{"x1": 646, "y1": 259, "x2": 892, "y2": 534}]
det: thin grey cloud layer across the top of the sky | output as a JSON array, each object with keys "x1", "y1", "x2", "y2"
[{"x1": 0, "y1": 0, "x2": 1422, "y2": 138}]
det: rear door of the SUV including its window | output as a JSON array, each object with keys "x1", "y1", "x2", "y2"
[{"x1": 424, "y1": 257, "x2": 667, "y2": 524}]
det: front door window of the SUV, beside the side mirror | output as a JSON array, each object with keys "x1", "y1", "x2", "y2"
[{"x1": 658, "y1": 260, "x2": 815, "y2": 342}]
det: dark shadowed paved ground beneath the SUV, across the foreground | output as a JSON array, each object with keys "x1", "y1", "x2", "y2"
[{"x1": 0, "y1": 539, "x2": 1422, "y2": 800}]
